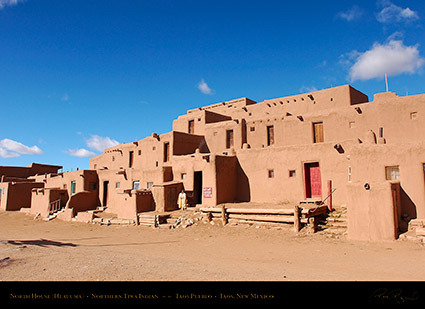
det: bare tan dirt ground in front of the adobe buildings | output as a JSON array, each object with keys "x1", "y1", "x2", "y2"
[{"x1": 0, "y1": 211, "x2": 425, "y2": 281}]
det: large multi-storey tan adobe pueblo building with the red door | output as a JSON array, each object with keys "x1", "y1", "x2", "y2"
[{"x1": 2, "y1": 85, "x2": 425, "y2": 240}]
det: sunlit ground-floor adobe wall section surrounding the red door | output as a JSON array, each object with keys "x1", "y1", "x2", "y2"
[{"x1": 237, "y1": 140, "x2": 357, "y2": 205}]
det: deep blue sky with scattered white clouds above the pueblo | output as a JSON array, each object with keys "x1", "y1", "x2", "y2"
[{"x1": 0, "y1": 0, "x2": 425, "y2": 171}]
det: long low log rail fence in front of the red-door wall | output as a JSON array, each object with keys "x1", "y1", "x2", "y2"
[{"x1": 200, "y1": 205, "x2": 328, "y2": 233}]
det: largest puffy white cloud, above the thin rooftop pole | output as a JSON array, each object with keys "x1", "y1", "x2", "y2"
[{"x1": 349, "y1": 40, "x2": 425, "y2": 81}]
